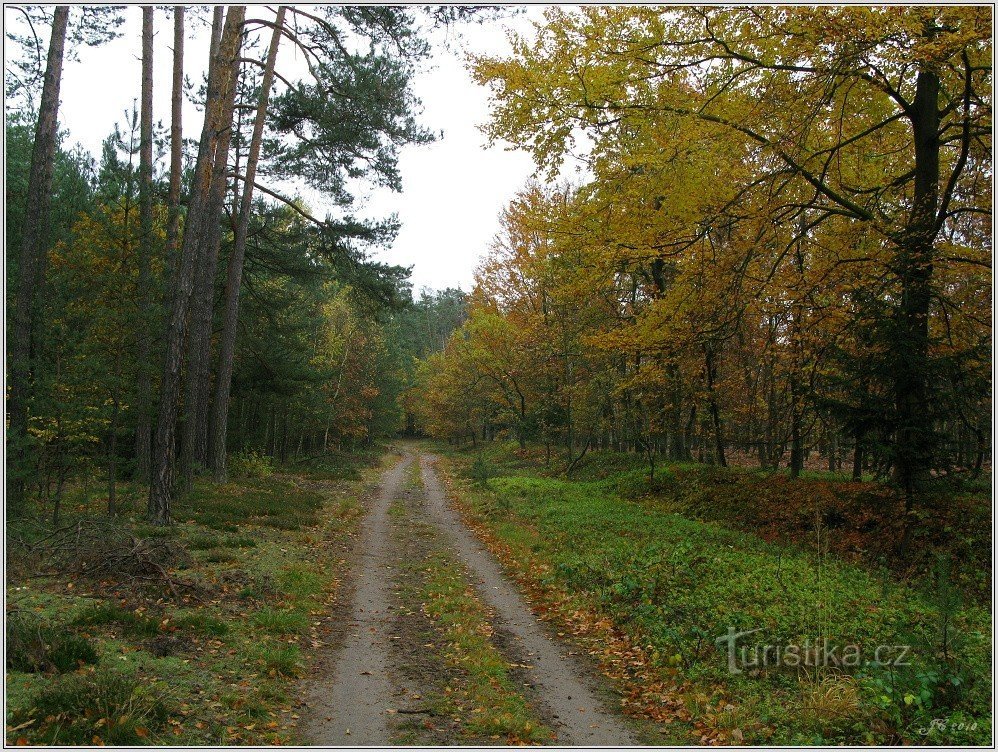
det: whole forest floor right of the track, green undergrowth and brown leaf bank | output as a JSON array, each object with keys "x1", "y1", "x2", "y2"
[{"x1": 428, "y1": 442, "x2": 993, "y2": 745}]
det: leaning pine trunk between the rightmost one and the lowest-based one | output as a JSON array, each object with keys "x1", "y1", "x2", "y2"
[{"x1": 180, "y1": 5, "x2": 246, "y2": 489}]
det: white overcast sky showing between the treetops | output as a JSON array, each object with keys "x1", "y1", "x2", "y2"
[{"x1": 5, "y1": 6, "x2": 556, "y2": 290}]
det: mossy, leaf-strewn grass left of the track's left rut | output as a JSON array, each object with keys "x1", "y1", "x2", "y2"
[{"x1": 7, "y1": 456, "x2": 388, "y2": 746}]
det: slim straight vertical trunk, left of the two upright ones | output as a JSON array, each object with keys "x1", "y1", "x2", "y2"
[{"x1": 135, "y1": 5, "x2": 153, "y2": 483}]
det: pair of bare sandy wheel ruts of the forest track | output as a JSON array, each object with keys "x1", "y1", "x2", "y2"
[{"x1": 302, "y1": 452, "x2": 636, "y2": 746}]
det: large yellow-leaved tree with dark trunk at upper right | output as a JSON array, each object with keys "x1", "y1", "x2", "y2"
[{"x1": 466, "y1": 7, "x2": 992, "y2": 508}]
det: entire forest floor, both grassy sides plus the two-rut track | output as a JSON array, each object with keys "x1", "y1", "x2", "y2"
[{"x1": 6, "y1": 442, "x2": 992, "y2": 746}]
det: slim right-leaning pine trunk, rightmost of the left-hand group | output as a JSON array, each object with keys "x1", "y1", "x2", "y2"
[{"x1": 211, "y1": 5, "x2": 286, "y2": 483}]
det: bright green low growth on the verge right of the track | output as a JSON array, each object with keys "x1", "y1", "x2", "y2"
[{"x1": 438, "y1": 450, "x2": 991, "y2": 744}]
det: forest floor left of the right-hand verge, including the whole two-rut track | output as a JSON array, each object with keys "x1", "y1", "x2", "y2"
[{"x1": 6, "y1": 445, "x2": 648, "y2": 746}]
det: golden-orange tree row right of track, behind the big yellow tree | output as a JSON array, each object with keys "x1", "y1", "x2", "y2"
[{"x1": 412, "y1": 121, "x2": 990, "y2": 496}]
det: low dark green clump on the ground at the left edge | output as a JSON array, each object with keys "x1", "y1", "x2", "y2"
[{"x1": 7, "y1": 614, "x2": 99, "y2": 673}]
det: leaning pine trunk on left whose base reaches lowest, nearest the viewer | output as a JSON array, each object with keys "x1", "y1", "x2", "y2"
[{"x1": 149, "y1": 6, "x2": 246, "y2": 525}]
